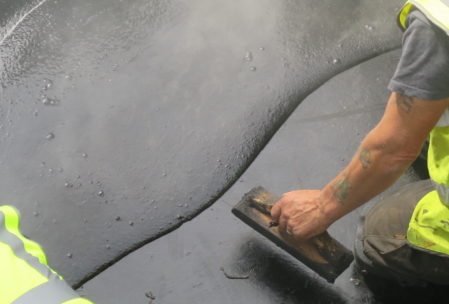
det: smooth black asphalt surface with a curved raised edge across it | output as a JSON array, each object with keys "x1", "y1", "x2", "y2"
[{"x1": 0, "y1": 0, "x2": 424, "y2": 303}]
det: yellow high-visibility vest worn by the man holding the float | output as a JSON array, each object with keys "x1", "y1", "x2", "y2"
[{"x1": 398, "y1": 0, "x2": 449, "y2": 255}]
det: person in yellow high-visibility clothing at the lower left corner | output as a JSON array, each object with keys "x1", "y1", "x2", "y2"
[{"x1": 0, "y1": 206, "x2": 92, "y2": 304}]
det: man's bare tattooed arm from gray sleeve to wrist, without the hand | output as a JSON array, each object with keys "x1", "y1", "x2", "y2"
[{"x1": 316, "y1": 93, "x2": 449, "y2": 224}]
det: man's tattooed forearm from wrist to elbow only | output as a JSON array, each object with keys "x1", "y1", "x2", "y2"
[{"x1": 321, "y1": 129, "x2": 417, "y2": 221}]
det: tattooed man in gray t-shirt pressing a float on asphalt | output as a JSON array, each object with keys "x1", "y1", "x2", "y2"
[{"x1": 272, "y1": 0, "x2": 449, "y2": 286}]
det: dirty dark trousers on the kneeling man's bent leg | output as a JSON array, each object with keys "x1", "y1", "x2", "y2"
[{"x1": 354, "y1": 180, "x2": 449, "y2": 286}]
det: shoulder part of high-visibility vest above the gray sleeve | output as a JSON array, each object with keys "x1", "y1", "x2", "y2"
[{"x1": 398, "y1": 0, "x2": 449, "y2": 35}]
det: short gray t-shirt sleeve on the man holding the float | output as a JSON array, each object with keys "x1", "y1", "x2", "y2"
[{"x1": 388, "y1": 10, "x2": 449, "y2": 100}]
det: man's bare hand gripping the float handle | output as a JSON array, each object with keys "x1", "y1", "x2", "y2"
[{"x1": 271, "y1": 190, "x2": 332, "y2": 240}]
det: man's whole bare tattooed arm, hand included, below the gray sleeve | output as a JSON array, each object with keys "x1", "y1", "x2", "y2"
[{"x1": 271, "y1": 93, "x2": 449, "y2": 239}]
